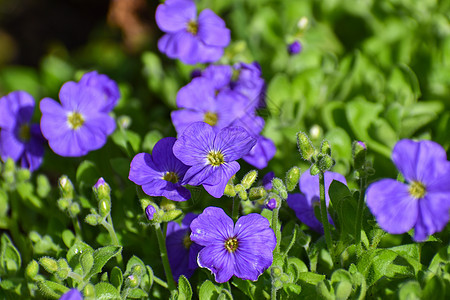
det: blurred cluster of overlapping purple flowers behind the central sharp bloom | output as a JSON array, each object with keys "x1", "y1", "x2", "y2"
[{"x1": 171, "y1": 63, "x2": 276, "y2": 169}]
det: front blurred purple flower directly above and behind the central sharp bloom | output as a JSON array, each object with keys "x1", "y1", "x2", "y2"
[{"x1": 171, "y1": 78, "x2": 245, "y2": 135}]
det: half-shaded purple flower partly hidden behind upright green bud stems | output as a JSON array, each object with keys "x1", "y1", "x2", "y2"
[{"x1": 287, "y1": 169, "x2": 347, "y2": 233}]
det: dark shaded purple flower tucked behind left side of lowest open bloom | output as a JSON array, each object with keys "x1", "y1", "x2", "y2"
[{"x1": 166, "y1": 213, "x2": 203, "y2": 281}]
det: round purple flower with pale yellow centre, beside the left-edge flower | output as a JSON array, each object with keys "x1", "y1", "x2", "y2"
[{"x1": 40, "y1": 81, "x2": 116, "y2": 156}]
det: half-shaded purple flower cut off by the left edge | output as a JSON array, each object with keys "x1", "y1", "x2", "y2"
[{"x1": 0, "y1": 91, "x2": 44, "y2": 171}]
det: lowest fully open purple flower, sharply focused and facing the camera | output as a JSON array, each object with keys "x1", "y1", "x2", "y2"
[{"x1": 191, "y1": 207, "x2": 277, "y2": 283}]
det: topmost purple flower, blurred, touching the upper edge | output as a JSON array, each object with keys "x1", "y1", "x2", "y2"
[{"x1": 155, "y1": 0, "x2": 230, "y2": 64}]
